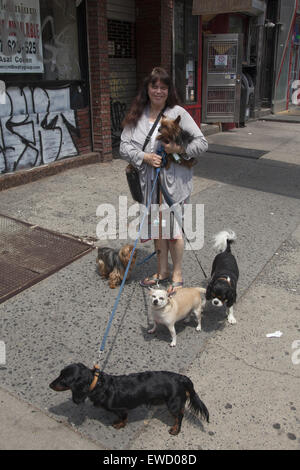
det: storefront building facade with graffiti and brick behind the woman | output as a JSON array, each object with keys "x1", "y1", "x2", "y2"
[{"x1": 0, "y1": 0, "x2": 300, "y2": 178}]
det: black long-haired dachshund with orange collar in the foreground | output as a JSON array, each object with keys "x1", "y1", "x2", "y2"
[{"x1": 50, "y1": 363, "x2": 209, "y2": 435}]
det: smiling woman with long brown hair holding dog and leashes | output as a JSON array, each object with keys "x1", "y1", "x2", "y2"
[{"x1": 120, "y1": 67, "x2": 207, "y2": 290}]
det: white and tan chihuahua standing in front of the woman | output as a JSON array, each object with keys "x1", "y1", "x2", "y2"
[{"x1": 148, "y1": 287, "x2": 206, "y2": 346}]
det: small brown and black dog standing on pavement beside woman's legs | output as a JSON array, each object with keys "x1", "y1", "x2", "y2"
[{"x1": 96, "y1": 245, "x2": 137, "y2": 289}]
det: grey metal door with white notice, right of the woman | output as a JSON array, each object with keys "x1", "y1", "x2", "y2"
[{"x1": 202, "y1": 34, "x2": 243, "y2": 122}]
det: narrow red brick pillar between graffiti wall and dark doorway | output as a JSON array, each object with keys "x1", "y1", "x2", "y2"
[{"x1": 86, "y1": 0, "x2": 112, "y2": 161}]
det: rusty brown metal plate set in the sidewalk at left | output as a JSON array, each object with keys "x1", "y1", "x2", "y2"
[{"x1": 0, "y1": 214, "x2": 93, "y2": 303}]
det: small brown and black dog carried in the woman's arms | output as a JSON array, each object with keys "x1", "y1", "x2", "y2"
[{"x1": 157, "y1": 115, "x2": 196, "y2": 169}]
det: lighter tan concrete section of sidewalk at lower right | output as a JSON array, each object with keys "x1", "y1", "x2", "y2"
[{"x1": 132, "y1": 225, "x2": 300, "y2": 450}]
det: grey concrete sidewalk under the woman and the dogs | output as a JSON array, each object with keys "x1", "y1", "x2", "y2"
[{"x1": 0, "y1": 116, "x2": 300, "y2": 451}]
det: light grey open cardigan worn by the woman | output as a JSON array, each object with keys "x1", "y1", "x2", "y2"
[{"x1": 120, "y1": 105, "x2": 208, "y2": 205}]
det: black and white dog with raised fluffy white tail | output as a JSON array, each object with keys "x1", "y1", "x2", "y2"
[{"x1": 206, "y1": 230, "x2": 239, "y2": 324}]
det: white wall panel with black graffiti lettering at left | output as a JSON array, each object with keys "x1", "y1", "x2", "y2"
[{"x1": 0, "y1": 86, "x2": 79, "y2": 173}]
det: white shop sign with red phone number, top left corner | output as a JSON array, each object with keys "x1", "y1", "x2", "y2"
[{"x1": 0, "y1": 0, "x2": 44, "y2": 73}]
